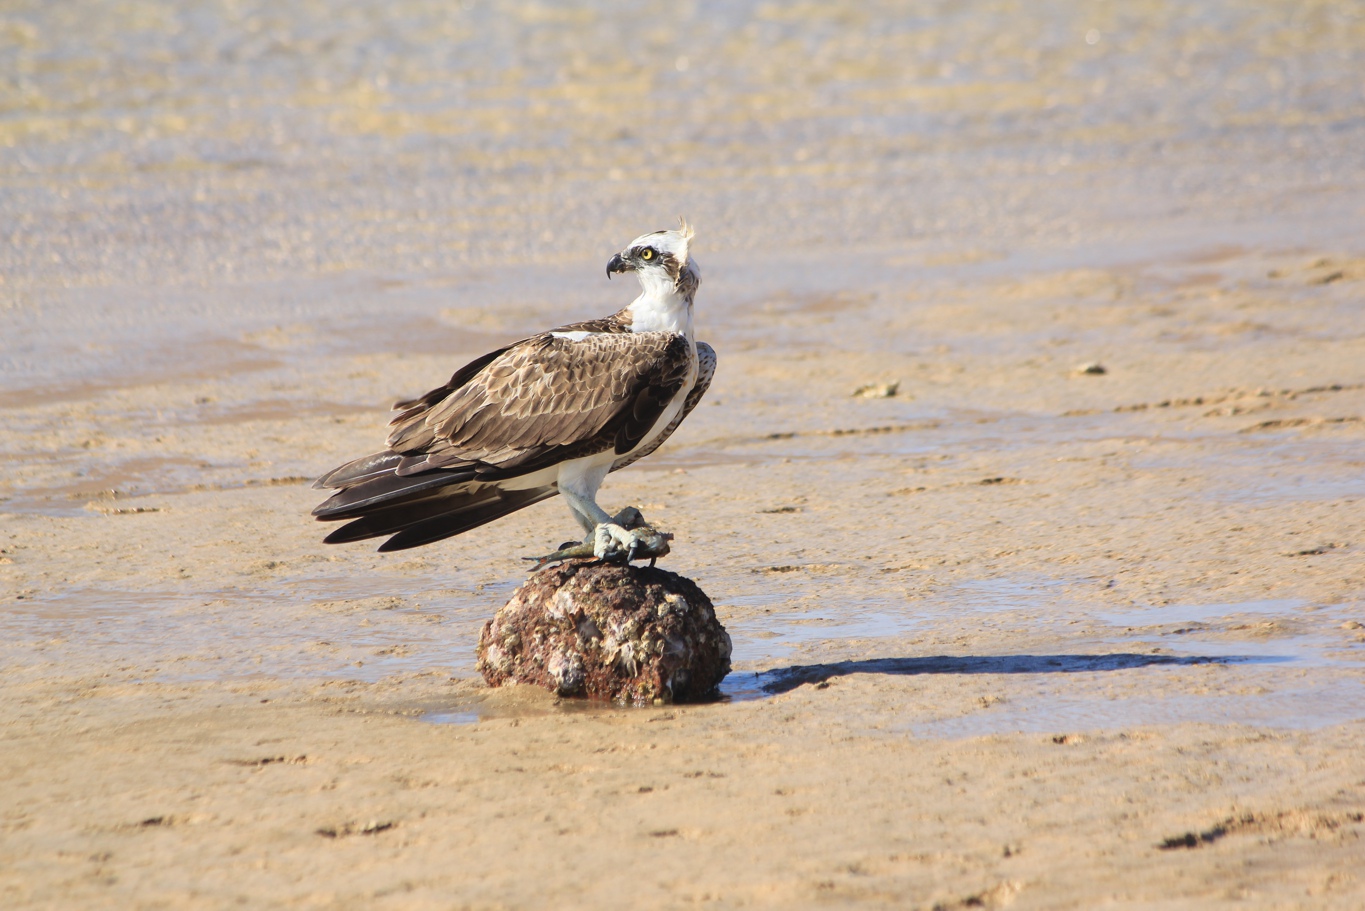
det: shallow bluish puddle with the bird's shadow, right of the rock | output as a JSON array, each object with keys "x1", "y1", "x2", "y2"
[{"x1": 721, "y1": 580, "x2": 1365, "y2": 736}]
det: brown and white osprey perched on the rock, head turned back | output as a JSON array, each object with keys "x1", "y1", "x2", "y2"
[{"x1": 313, "y1": 221, "x2": 715, "y2": 560}]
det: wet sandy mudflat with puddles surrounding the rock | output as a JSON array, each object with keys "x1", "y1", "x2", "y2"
[{"x1": 0, "y1": 239, "x2": 1365, "y2": 908}]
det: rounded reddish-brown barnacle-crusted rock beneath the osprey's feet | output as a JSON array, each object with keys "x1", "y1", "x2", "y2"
[{"x1": 478, "y1": 560, "x2": 730, "y2": 705}]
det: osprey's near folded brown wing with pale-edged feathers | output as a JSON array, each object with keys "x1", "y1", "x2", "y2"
[{"x1": 389, "y1": 333, "x2": 691, "y2": 478}]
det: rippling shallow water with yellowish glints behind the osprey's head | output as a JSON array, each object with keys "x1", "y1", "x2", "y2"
[{"x1": 0, "y1": 0, "x2": 1365, "y2": 366}]
